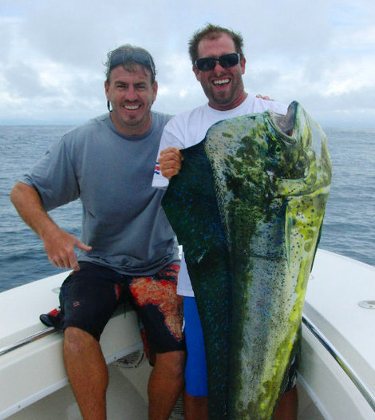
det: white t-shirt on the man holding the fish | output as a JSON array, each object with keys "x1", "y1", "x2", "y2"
[{"x1": 152, "y1": 96, "x2": 288, "y2": 296}]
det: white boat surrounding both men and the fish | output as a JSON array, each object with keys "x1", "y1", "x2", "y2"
[{"x1": 0, "y1": 250, "x2": 375, "y2": 420}]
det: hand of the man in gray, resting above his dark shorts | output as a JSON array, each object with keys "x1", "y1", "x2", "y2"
[{"x1": 42, "y1": 227, "x2": 91, "y2": 271}]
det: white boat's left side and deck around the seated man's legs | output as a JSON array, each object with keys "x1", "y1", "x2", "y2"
[{"x1": 0, "y1": 273, "x2": 150, "y2": 420}]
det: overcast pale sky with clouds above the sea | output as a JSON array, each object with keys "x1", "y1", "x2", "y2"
[{"x1": 0, "y1": 0, "x2": 375, "y2": 127}]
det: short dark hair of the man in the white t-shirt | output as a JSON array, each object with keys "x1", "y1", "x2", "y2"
[{"x1": 189, "y1": 23, "x2": 244, "y2": 64}]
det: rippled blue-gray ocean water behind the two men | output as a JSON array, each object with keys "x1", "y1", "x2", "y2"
[{"x1": 0, "y1": 126, "x2": 375, "y2": 292}]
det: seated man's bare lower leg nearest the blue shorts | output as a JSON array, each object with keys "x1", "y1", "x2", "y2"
[{"x1": 148, "y1": 351, "x2": 186, "y2": 420}]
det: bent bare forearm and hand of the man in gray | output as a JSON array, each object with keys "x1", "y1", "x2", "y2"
[{"x1": 10, "y1": 182, "x2": 91, "y2": 271}]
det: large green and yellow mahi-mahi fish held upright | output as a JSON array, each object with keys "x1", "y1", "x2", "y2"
[{"x1": 163, "y1": 102, "x2": 331, "y2": 420}]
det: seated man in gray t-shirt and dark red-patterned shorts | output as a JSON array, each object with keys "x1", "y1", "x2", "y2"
[{"x1": 11, "y1": 45, "x2": 185, "y2": 420}]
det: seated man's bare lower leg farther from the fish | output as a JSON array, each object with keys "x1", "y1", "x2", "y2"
[{"x1": 64, "y1": 327, "x2": 108, "y2": 420}]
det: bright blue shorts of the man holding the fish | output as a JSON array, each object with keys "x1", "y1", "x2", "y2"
[{"x1": 184, "y1": 296, "x2": 301, "y2": 397}]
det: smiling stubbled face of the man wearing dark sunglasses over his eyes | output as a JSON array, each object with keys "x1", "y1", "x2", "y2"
[{"x1": 193, "y1": 34, "x2": 247, "y2": 111}]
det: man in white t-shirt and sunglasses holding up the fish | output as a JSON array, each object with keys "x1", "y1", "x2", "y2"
[{"x1": 153, "y1": 24, "x2": 297, "y2": 420}]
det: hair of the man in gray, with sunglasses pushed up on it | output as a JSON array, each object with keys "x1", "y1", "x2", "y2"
[{"x1": 105, "y1": 44, "x2": 156, "y2": 83}]
